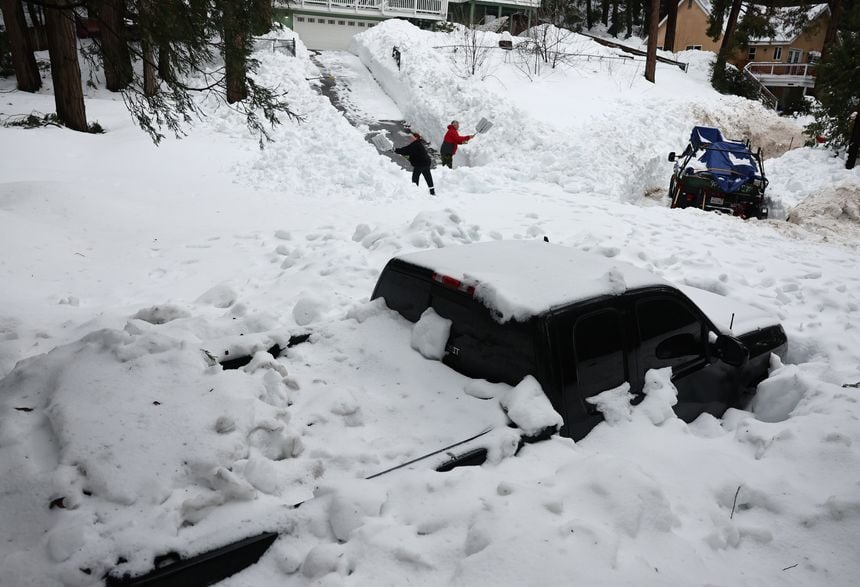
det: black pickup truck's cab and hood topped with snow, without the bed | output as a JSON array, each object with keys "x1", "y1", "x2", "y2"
[{"x1": 373, "y1": 241, "x2": 786, "y2": 439}]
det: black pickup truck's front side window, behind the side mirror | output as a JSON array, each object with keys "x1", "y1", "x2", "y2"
[{"x1": 636, "y1": 298, "x2": 705, "y2": 373}]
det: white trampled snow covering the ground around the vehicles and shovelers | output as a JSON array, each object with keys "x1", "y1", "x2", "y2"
[{"x1": 0, "y1": 21, "x2": 860, "y2": 585}]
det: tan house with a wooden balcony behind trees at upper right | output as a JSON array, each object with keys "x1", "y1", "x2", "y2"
[{"x1": 657, "y1": 0, "x2": 830, "y2": 105}]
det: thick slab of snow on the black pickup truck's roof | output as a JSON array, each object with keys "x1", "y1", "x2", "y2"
[{"x1": 397, "y1": 240, "x2": 670, "y2": 321}]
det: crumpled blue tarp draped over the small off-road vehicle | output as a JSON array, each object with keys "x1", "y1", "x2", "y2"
[{"x1": 690, "y1": 126, "x2": 758, "y2": 194}]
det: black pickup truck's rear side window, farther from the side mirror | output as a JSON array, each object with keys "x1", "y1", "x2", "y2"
[{"x1": 573, "y1": 309, "x2": 628, "y2": 397}]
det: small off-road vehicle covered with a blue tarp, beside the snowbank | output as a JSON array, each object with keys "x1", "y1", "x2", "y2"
[{"x1": 669, "y1": 126, "x2": 768, "y2": 220}]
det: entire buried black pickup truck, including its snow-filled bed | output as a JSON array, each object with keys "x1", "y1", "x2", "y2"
[{"x1": 108, "y1": 241, "x2": 786, "y2": 586}]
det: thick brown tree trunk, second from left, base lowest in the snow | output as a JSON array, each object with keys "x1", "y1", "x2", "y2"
[{"x1": 45, "y1": 0, "x2": 88, "y2": 132}]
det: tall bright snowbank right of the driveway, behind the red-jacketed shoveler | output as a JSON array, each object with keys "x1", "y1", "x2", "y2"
[{"x1": 353, "y1": 21, "x2": 801, "y2": 207}]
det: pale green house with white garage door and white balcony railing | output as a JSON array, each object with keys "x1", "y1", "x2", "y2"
[{"x1": 273, "y1": 0, "x2": 540, "y2": 50}]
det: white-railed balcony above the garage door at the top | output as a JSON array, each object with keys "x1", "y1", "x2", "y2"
[{"x1": 286, "y1": 0, "x2": 448, "y2": 20}]
